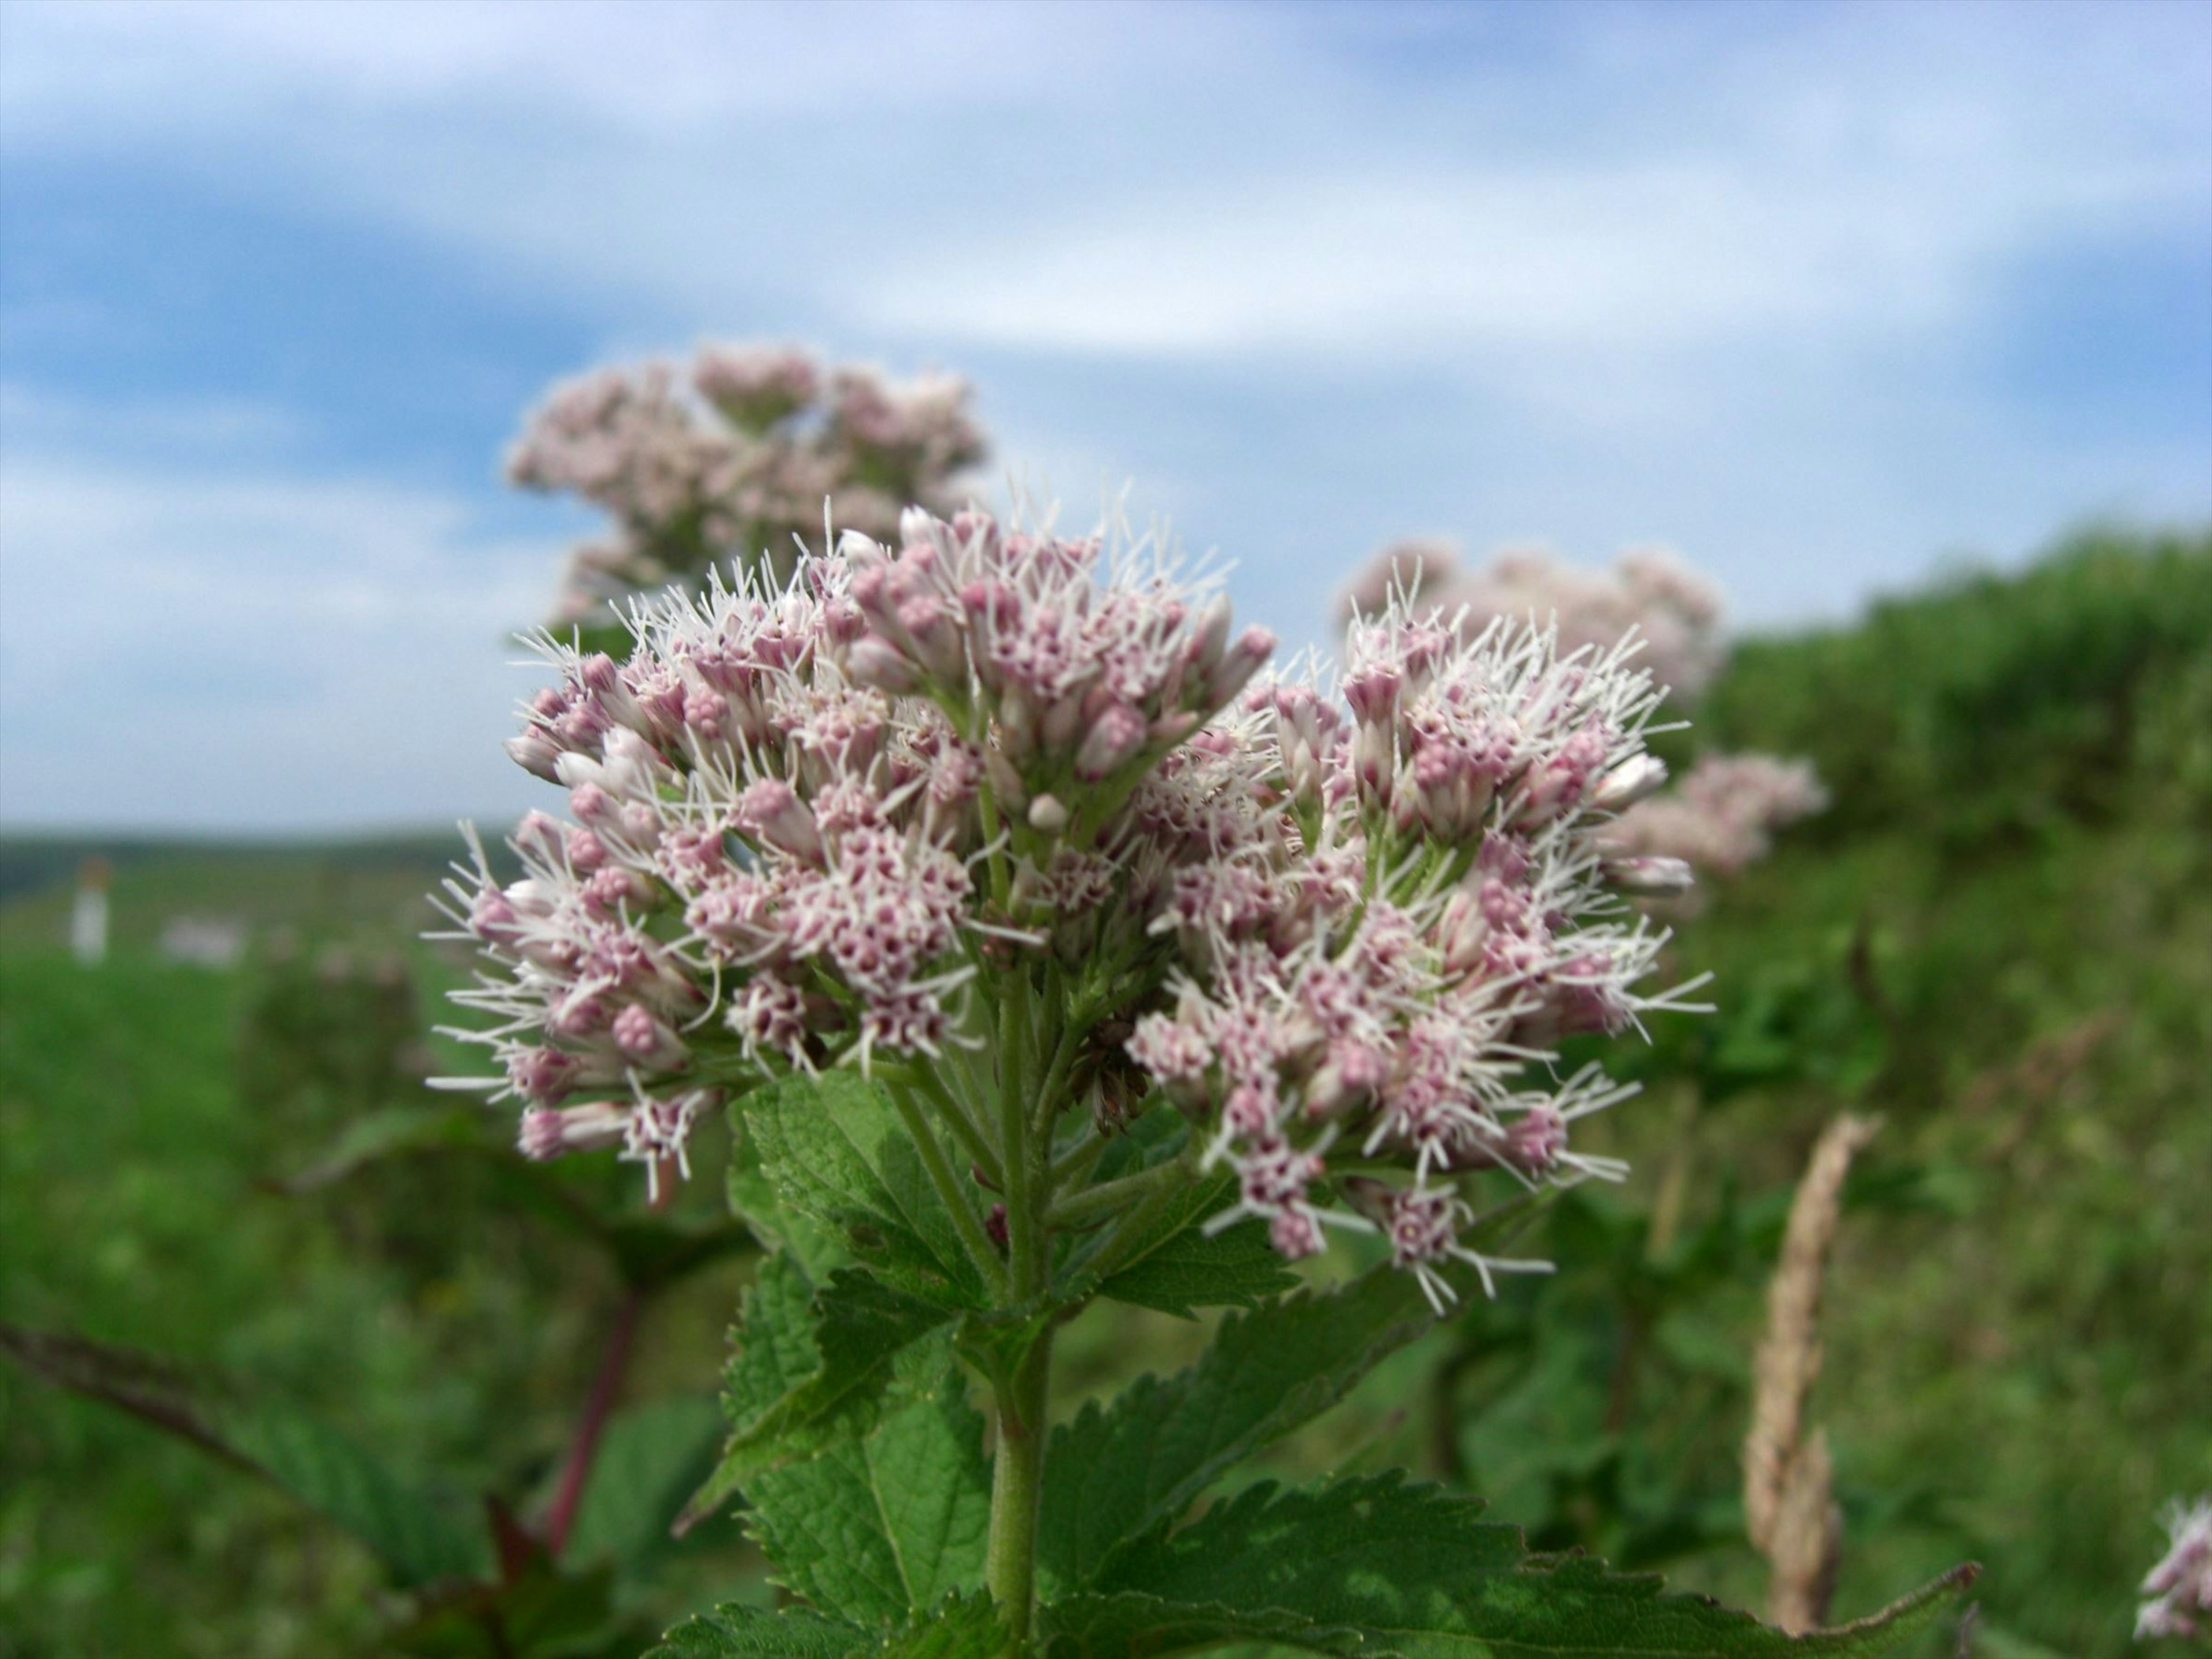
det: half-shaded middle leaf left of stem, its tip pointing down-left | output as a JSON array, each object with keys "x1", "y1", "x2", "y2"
[{"x1": 677, "y1": 1254, "x2": 953, "y2": 1528}]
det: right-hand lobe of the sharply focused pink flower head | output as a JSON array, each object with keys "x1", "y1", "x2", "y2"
[{"x1": 1128, "y1": 606, "x2": 1688, "y2": 1301}]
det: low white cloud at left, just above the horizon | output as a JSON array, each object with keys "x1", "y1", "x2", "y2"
[{"x1": 0, "y1": 438, "x2": 555, "y2": 830}]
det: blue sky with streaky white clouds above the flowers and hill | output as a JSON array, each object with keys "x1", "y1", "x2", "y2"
[{"x1": 0, "y1": 0, "x2": 2212, "y2": 830}]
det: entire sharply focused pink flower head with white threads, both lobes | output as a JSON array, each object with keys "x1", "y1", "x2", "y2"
[{"x1": 449, "y1": 506, "x2": 1688, "y2": 1296}]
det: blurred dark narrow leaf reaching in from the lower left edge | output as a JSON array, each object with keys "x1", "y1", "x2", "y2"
[{"x1": 0, "y1": 1325, "x2": 489, "y2": 1588}]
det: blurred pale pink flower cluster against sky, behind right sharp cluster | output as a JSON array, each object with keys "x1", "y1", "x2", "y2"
[{"x1": 1338, "y1": 537, "x2": 1728, "y2": 703}]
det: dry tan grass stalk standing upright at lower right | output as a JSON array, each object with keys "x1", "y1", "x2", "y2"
[{"x1": 1743, "y1": 1115, "x2": 1878, "y2": 1633}]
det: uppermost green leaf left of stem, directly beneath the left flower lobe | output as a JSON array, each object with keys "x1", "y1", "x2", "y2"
[{"x1": 739, "y1": 1071, "x2": 987, "y2": 1307}]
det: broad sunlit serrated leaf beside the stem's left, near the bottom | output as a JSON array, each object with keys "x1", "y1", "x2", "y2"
[{"x1": 745, "y1": 1334, "x2": 991, "y2": 1619}]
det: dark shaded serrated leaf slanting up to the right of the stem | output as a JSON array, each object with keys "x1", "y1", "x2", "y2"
[{"x1": 1037, "y1": 1267, "x2": 1435, "y2": 1593}]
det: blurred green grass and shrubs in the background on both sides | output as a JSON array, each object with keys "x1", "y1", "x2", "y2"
[{"x1": 0, "y1": 531, "x2": 2212, "y2": 1659}]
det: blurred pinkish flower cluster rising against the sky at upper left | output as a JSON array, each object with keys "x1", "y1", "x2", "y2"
[{"x1": 506, "y1": 345, "x2": 984, "y2": 624}]
